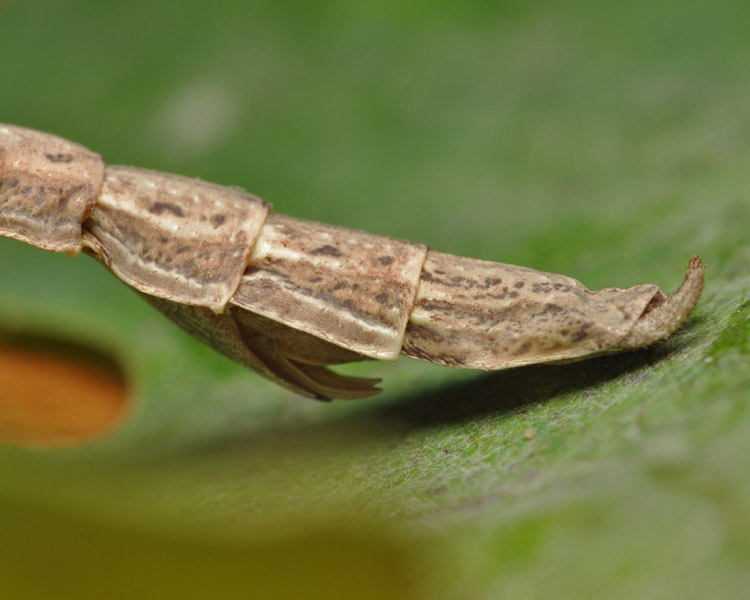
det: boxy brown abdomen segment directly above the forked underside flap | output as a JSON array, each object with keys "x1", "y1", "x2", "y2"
[{"x1": 232, "y1": 214, "x2": 427, "y2": 360}]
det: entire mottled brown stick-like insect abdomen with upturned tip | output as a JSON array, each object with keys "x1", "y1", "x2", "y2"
[{"x1": 0, "y1": 125, "x2": 704, "y2": 398}]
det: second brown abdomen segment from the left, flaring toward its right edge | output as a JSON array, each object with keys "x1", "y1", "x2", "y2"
[{"x1": 85, "y1": 167, "x2": 269, "y2": 312}]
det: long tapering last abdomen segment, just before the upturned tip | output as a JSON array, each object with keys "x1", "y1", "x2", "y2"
[{"x1": 403, "y1": 252, "x2": 661, "y2": 370}]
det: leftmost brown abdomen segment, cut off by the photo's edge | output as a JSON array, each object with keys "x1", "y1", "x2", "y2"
[{"x1": 0, "y1": 124, "x2": 104, "y2": 255}]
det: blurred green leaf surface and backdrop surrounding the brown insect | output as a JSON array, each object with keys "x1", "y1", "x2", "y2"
[{"x1": 0, "y1": 0, "x2": 750, "y2": 599}]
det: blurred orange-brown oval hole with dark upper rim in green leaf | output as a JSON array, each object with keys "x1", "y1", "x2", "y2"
[{"x1": 0, "y1": 332, "x2": 127, "y2": 447}]
